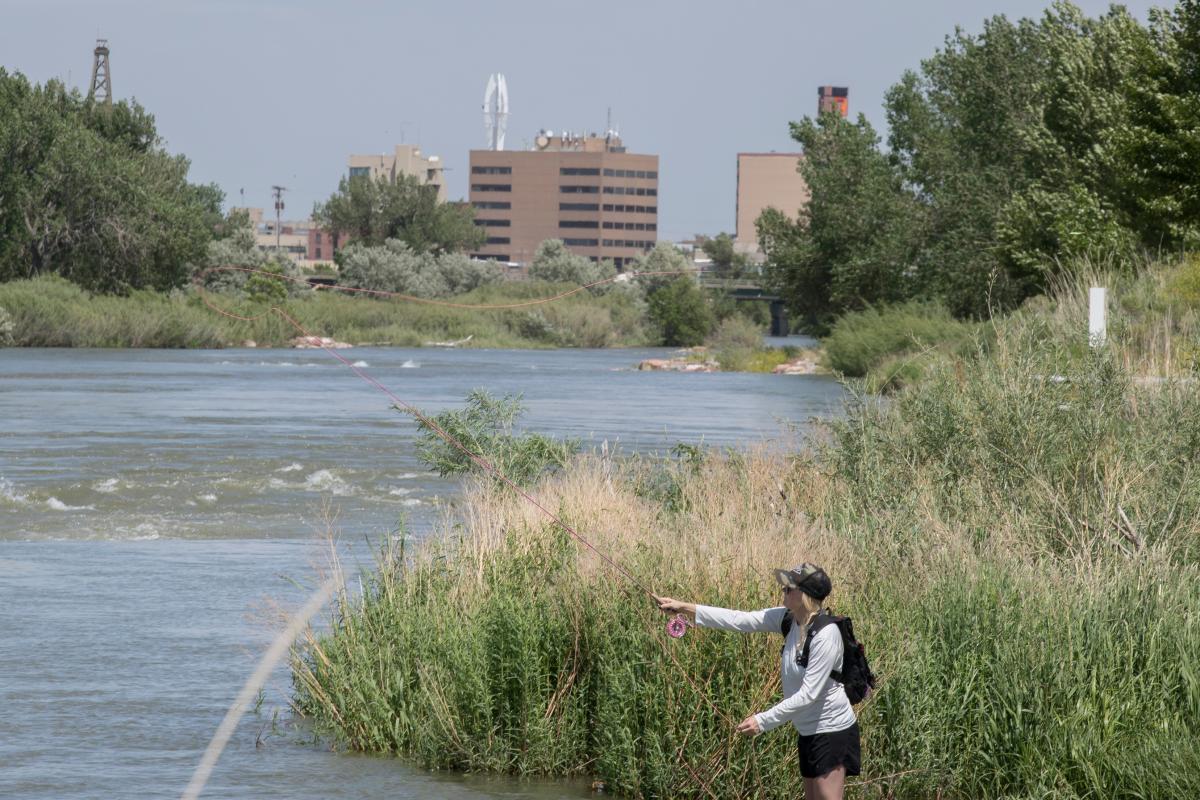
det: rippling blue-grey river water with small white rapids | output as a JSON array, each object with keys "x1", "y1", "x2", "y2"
[{"x1": 0, "y1": 348, "x2": 842, "y2": 800}]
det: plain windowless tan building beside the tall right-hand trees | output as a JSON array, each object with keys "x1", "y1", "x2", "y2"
[{"x1": 733, "y1": 152, "x2": 810, "y2": 254}]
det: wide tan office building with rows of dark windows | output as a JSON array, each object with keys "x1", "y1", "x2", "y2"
[{"x1": 469, "y1": 132, "x2": 659, "y2": 269}]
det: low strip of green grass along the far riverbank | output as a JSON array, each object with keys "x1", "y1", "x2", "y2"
[{"x1": 0, "y1": 277, "x2": 649, "y2": 348}]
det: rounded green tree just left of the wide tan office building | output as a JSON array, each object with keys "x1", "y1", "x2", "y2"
[{"x1": 313, "y1": 174, "x2": 487, "y2": 253}]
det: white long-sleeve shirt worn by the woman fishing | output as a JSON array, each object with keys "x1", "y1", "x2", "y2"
[{"x1": 696, "y1": 606, "x2": 857, "y2": 735}]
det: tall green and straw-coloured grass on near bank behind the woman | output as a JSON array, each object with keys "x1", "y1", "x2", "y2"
[{"x1": 294, "y1": 272, "x2": 1200, "y2": 799}]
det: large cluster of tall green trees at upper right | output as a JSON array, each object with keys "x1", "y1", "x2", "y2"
[{"x1": 757, "y1": 0, "x2": 1200, "y2": 331}]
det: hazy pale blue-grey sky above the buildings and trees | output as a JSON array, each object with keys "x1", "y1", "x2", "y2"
[{"x1": 0, "y1": 0, "x2": 1163, "y2": 240}]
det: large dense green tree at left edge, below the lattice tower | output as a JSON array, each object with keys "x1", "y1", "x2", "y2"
[{"x1": 0, "y1": 70, "x2": 222, "y2": 291}]
